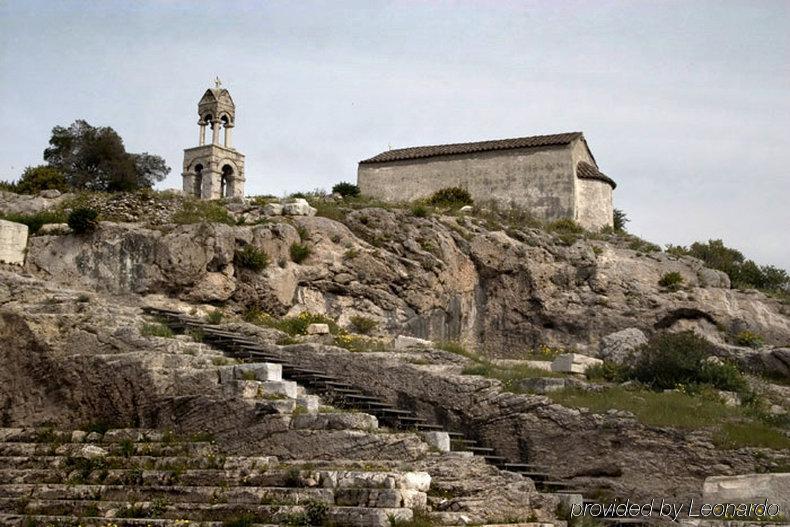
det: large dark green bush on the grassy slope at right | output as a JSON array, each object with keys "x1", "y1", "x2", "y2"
[{"x1": 628, "y1": 331, "x2": 746, "y2": 392}]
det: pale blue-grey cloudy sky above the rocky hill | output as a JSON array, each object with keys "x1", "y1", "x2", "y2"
[{"x1": 0, "y1": 0, "x2": 790, "y2": 269}]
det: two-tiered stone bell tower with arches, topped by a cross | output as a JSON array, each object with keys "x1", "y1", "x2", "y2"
[{"x1": 182, "y1": 78, "x2": 244, "y2": 199}]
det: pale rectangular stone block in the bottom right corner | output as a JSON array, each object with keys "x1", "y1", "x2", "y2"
[{"x1": 702, "y1": 472, "x2": 790, "y2": 511}]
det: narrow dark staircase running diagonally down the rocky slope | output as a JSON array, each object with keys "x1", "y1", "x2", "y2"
[{"x1": 144, "y1": 307, "x2": 644, "y2": 526}]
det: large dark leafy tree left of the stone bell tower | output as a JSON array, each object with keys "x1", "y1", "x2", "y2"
[{"x1": 44, "y1": 120, "x2": 170, "y2": 192}]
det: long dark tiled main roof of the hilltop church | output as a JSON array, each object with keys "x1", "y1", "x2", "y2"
[{"x1": 360, "y1": 132, "x2": 584, "y2": 164}]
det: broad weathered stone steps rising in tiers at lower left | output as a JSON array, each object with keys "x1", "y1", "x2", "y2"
[{"x1": 0, "y1": 428, "x2": 430, "y2": 527}]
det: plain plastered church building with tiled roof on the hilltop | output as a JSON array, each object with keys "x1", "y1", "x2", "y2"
[{"x1": 357, "y1": 132, "x2": 617, "y2": 230}]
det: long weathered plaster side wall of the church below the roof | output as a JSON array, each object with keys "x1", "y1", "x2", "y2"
[{"x1": 357, "y1": 146, "x2": 575, "y2": 221}]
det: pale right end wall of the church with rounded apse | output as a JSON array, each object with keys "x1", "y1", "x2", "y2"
[{"x1": 571, "y1": 139, "x2": 614, "y2": 231}]
